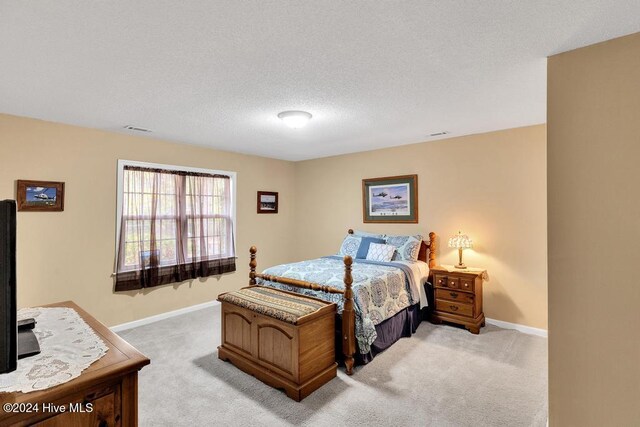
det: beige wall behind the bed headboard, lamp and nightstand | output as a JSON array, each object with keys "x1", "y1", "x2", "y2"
[{"x1": 295, "y1": 125, "x2": 547, "y2": 329}]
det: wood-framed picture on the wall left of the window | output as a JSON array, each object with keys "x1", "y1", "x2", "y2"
[{"x1": 16, "y1": 179, "x2": 64, "y2": 212}]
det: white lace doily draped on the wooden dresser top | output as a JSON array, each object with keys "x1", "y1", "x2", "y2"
[{"x1": 0, "y1": 307, "x2": 108, "y2": 393}]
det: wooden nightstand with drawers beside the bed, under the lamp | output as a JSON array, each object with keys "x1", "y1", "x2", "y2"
[{"x1": 431, "y1": 265, "x2": 487, "y2": 334}]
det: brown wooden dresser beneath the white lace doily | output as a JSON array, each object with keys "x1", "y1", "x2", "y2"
[{"x1": 0, "y1": 301, "x2": 150, "y2": 427}]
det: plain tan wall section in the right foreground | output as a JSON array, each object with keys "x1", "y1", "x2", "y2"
[{"x1": 548, "y1": 33, "x2": 640, "y2": 426}]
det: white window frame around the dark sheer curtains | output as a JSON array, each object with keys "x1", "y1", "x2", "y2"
[{"x1": 115, "y1": 159, "x2": 237, "y2": 268}]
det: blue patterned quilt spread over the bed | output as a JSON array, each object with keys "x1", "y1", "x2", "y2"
[{"x1": 258, "y1": 256, "x2": 420, "y2": 353}]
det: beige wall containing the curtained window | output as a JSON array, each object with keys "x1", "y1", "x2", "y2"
[{"x1": 0, "y1": 115, "x2": 295, "y2": 325}]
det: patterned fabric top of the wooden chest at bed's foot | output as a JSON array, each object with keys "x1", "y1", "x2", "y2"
[{"x1": 218, "y1": 286, "x2": 326, "y2": 325}]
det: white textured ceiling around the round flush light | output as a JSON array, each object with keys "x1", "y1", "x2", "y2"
[{"x1": 0, "y1": 0, "x2": 640, "y2": 160}]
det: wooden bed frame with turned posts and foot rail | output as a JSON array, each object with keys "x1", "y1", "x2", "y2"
[{"x1": 249, "y1": 229, "x2": 436, "y2": 375}]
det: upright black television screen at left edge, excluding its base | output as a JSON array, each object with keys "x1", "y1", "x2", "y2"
[{"x1": 0, "y1": 200, "x2": 18, "y2": 374}]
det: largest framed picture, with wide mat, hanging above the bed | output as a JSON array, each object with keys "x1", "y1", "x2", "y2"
[{"x1": 362, "y1": 175, "x2": 418, "y2": 223}]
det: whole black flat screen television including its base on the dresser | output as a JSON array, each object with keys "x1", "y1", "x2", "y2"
[{"x1": 0, "y1": 200, "x2": 40, "y2": 374}]
